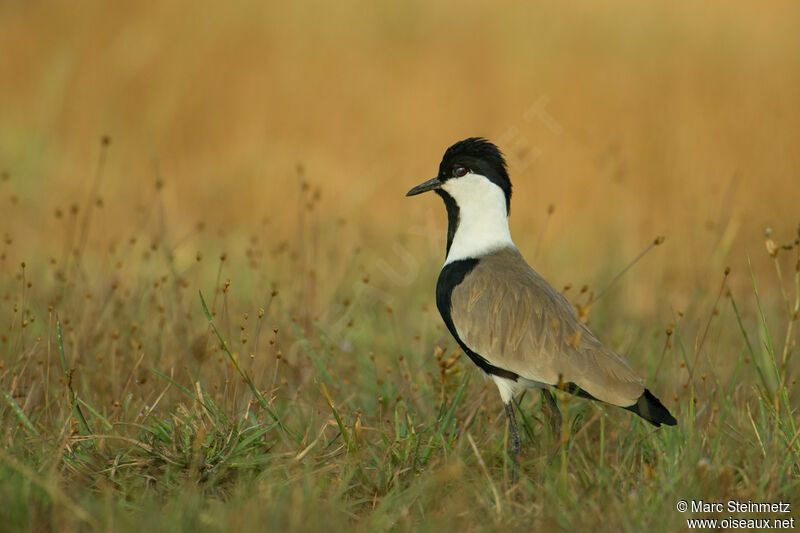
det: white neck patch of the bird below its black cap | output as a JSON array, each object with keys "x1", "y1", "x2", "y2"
[{"x1": 442, "y1": 173, "x2": 514, "y2": 265}]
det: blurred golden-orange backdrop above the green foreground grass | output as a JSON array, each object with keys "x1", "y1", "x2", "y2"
[{"x1": 0, "y1": 1, "x2": 800, "y2": 314}]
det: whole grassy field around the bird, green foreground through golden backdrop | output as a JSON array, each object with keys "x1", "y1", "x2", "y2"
[{"x1": 0, "y1": 1, "x2": 800, "y2": 531}]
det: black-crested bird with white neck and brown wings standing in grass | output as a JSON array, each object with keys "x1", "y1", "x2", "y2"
[{"x1": 406, "y1": 137, "x2": 677, "y2": 479}]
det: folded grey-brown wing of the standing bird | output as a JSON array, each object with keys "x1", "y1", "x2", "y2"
[{"x1": 451, "y1": 248, "x2": 644, "y2": 407}]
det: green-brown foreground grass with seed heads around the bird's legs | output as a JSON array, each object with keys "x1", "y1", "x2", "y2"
[{"x1": 0, "y1": 153, "x2": 800, "y2": 531}]
